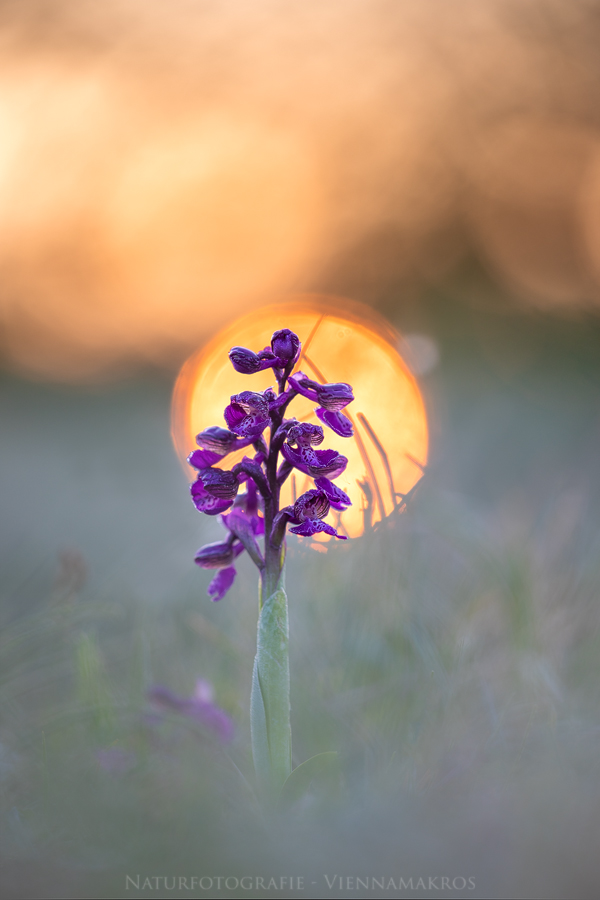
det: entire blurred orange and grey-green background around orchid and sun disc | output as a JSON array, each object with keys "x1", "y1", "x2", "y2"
[{"x1": 0, "y1": 0, "x2": 600, "y2": 900}]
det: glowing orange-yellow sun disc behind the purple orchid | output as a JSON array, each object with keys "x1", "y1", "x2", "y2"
[{"x1": 171, "y1": 295, "x2": 428, "y2": 537}]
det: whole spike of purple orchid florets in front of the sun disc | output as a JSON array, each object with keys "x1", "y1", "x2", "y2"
[{"x1": 188, "y1": 328, "x2": 354, "y2": 600}]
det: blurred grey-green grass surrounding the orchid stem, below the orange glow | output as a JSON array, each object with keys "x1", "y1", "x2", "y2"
[{"x1": 0, "y1": 280, "x2": 600, "y2": 898}]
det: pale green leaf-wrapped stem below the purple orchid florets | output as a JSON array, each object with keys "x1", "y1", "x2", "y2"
[{"x1": 250, "y1": 552, "x2": 292, "y2": 804}]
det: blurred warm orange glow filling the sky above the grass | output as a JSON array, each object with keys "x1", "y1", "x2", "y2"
[{"x1": 0, "y1": 0, "x2": 600, "y2": 382}]
